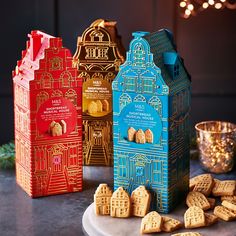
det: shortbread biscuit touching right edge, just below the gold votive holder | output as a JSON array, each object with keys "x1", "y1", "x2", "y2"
[{"x1": 212, "y1": 180, "x2": 235, "y2": 197}]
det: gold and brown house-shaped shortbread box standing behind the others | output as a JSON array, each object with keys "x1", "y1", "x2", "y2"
[{"x1": 73, "y1": 19, "x2": 125, "y2": 166}]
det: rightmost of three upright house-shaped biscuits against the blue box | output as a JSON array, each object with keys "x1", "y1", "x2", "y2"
[{"x1": 131, "y1": 185, "x2": 151, "y2": 217}]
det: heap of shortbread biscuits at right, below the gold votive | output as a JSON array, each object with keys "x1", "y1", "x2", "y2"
[{"x1": 184, "y1": 174, "x2": 236, "y2": 228}]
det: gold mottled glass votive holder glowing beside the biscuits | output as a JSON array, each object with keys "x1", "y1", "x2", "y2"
[{"x1": 195, "y1": 121, "x2": 236, "y2": 174}]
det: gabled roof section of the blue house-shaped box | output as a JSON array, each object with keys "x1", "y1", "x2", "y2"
[{"x1": 112, "y1": 29, "x2": 191, "y2": 94}]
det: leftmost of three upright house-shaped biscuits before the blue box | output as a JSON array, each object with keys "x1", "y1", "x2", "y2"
[{"x1": 94, "y1": 184, "x2": 112, "y2": 215}]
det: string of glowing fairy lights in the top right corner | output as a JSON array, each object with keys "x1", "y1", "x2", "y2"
[{"x1": 179, "y1": 0, "x2": 236, "y2": 19}]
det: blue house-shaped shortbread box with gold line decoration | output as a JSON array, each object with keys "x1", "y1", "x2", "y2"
[{"x1": 112, "y1": 29, "x2": 191, "y2": 213}]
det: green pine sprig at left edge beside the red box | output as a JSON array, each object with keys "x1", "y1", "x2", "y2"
[{"x1": 0, "y1": 141, "x2": 15, "y2": 169}]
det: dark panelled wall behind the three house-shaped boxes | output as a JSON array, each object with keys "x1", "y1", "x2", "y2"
[{"x1": 0, "y1": 0, "x2": 236, "y2": 143}]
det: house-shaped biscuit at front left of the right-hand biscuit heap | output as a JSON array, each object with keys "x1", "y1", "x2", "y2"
[{"x1": 184, "y1": 206, "x2": 205, "y2": 229}]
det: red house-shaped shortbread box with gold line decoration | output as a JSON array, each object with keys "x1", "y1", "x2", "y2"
[{"x1": 13, "y1": 31, "x2": 82, "y2": 197}]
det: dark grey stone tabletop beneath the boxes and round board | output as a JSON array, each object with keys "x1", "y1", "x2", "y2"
[{"x1": 0, "y1": 160, "x2": 236, "y2": 236}]
